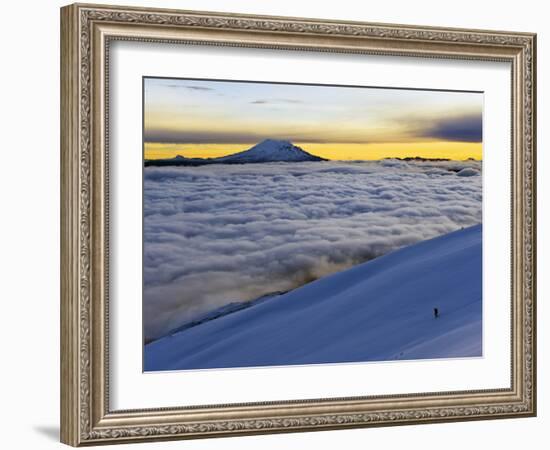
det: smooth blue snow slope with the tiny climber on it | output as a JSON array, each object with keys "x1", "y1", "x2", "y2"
[{"x1": 144, "y1": 225, "x2": 482, "y2": 371}]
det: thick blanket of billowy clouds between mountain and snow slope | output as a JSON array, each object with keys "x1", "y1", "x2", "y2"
[{"x1": 143, "y1": 160, "x2": 482, "y2": 340}]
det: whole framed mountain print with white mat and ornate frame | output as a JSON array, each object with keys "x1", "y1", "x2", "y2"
[{"x1": 61, "y1": 4, "x2": 536, "y2": 446}]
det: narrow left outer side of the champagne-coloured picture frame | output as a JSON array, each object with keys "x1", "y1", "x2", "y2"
[{"x1": 60, "y1": 5, "x2": 80, "y2": 446}]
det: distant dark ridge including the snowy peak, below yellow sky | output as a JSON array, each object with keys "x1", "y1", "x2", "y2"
[{"x1": 145, "y1": 139, "x2": 326, "y2": 166}]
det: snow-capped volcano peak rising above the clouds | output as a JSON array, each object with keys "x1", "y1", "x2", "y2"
[{"x1": 216, "y1": 139, "x2": 323, "y2": 163}]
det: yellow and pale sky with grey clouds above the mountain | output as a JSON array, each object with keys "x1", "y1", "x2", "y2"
[{"x1": 143, "y1": 78, "x2": 483, "y2": 160}]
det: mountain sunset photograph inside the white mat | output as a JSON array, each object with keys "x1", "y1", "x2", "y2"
[{"x1": 144, "y1": 76, "x2": 484, "y2": 372}]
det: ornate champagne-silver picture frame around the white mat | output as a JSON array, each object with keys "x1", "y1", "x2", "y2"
[{"x1": 61, "y1": 4, "x2": 536, "y2": 446}]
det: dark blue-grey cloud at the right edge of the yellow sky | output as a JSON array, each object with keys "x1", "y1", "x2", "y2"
[{"x1": 422, "y1": 114, "x2": 483, "y2": 142}]
